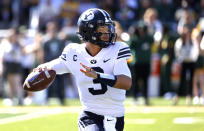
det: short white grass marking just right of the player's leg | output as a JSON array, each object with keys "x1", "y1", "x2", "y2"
[{"x1": 125, "y1": 118, "x2": 156, "y2": 125}]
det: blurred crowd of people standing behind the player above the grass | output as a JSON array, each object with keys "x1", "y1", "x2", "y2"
[{"x1": 0, "y1": 0, "x2": 204, "y2": 106}]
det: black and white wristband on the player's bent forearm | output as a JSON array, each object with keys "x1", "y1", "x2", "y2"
[{"x1": 94, "y1": 73, "x2": 117, "y2": 87}]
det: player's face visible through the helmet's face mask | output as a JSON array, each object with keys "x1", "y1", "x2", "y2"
[{"x1": 96, "y1": 26, "x2": 109, "y2": 41}]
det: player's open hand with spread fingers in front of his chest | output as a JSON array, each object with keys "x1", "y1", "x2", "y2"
[{"x1": 80, "y1": 63, "x2": 97, "y2": 79}]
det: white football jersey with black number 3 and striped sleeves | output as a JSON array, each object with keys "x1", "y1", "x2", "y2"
[{"x1": 48, "y1": 42, "x2": 131, "y2": 117}]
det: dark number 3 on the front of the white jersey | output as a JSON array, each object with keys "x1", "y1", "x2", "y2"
[{"x1": 89, "y1": 67, "x2": 108, "y2": 95}]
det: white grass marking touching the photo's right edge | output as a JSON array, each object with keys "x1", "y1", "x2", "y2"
[{"x1": 173, "y1": 117, "x2": 204, "y2": 124}]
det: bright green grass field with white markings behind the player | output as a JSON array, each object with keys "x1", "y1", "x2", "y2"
[{"x1": 0, "y1": 98, "x2": 204, "y2": 131}]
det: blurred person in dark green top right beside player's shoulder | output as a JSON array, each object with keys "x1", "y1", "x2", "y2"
[{"x1": 129, "y1": 21, "x2": 153, "y2": 105}]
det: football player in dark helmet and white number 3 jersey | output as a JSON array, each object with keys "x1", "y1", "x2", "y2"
[{"x1": 35, "y1": 8, "x2": 132, "y2": 131}]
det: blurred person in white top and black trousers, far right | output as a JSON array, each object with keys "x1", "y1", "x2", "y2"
[{"x1": 174, "y1": 25, "x2": 199, "y2": 105}]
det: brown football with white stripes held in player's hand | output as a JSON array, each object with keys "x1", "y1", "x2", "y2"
[{"x1": 23, "y1": 70, "x2": 56, "y2": 92}]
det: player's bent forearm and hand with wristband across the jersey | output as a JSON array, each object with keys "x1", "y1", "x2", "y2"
[{"x1": 80, "y1": 63, "x2": 132, "y2": 90}]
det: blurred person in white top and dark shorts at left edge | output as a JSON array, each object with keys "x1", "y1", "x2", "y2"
[{"x1": 0, "y1": 29, "x2": 23, "y2": 105}]
